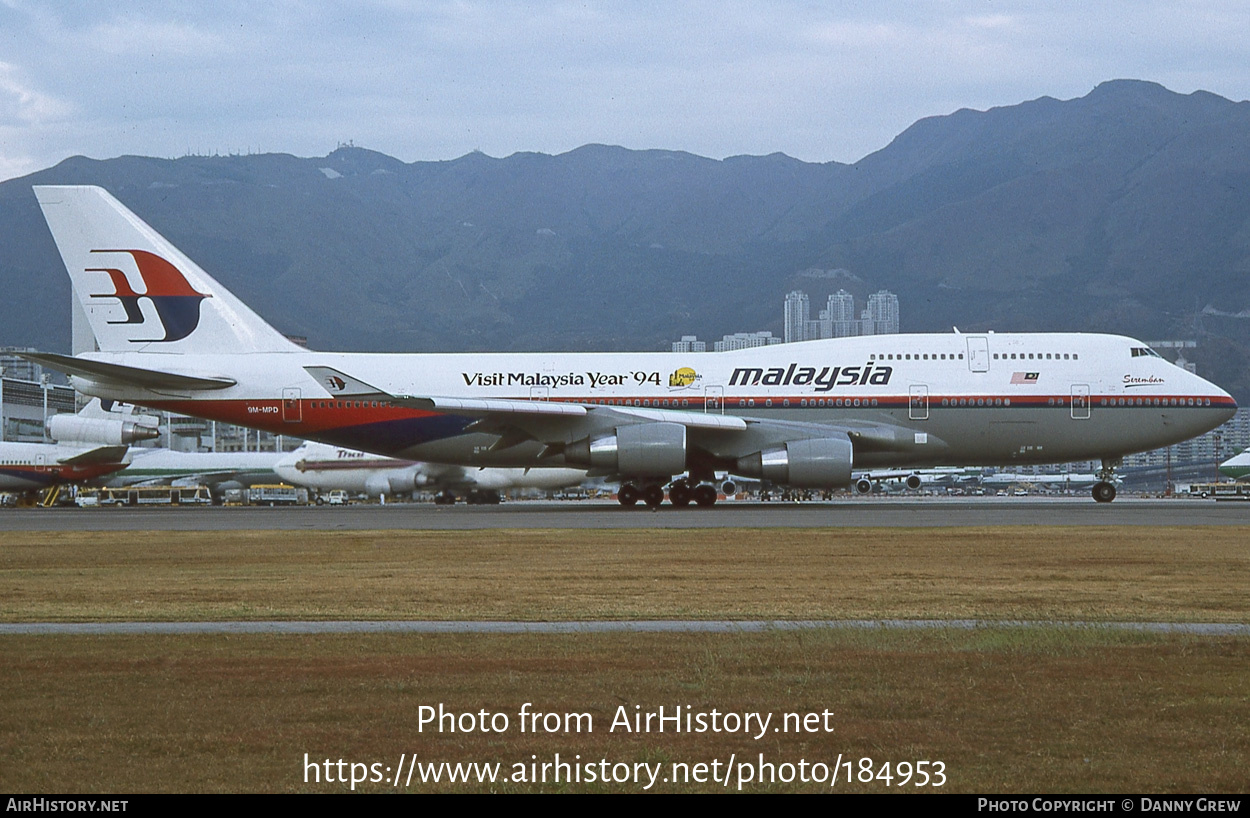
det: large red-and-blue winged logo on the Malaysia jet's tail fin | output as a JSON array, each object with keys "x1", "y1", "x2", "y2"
[{"x1": 86, "y1": 250, "x2": 211, "y2": 344}]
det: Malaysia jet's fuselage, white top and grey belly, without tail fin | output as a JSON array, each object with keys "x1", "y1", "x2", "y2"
[{"x1": 74, "y1": 333, "x2": 1236, "y2": 468}]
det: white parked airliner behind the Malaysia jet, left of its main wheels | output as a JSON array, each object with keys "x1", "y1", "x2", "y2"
[{"x1": 275, "y1": 443, "x2": 586, "y2": 505}]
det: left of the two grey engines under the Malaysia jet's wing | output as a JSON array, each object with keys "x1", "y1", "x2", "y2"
[{"x1": 564, "y1": 423, "x2": 686, "y2": 478}]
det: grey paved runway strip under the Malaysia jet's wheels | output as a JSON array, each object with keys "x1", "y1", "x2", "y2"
[{"x1": 0, "y1": 498, "x2": 1250, "y2": 532}]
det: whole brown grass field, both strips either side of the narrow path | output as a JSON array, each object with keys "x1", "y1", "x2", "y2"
[{"x1": 0, "y1": 528, "x2": 1250, "y2": 793}]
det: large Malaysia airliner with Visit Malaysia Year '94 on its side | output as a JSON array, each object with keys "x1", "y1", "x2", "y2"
[{"x1": 26, "y1": 186, "x2": 1236, "y2": 507}]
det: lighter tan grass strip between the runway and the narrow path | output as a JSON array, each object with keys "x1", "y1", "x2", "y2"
[{"x1": 0, "y1": 527, "x2": 1250, "y2": 622}]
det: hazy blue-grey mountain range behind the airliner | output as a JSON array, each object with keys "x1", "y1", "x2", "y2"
[{"x1": 0, "y1": 80, "x2": 1250, "y2": 403}]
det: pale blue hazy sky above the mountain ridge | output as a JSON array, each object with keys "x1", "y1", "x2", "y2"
[{"x1": 0, "y1": 0, "x2": 1250, "y2": 179}]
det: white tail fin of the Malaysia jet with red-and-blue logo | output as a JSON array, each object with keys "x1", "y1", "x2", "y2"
[{"x1": 35, "y1": 186, "x2": 299, "y2": 353}]
